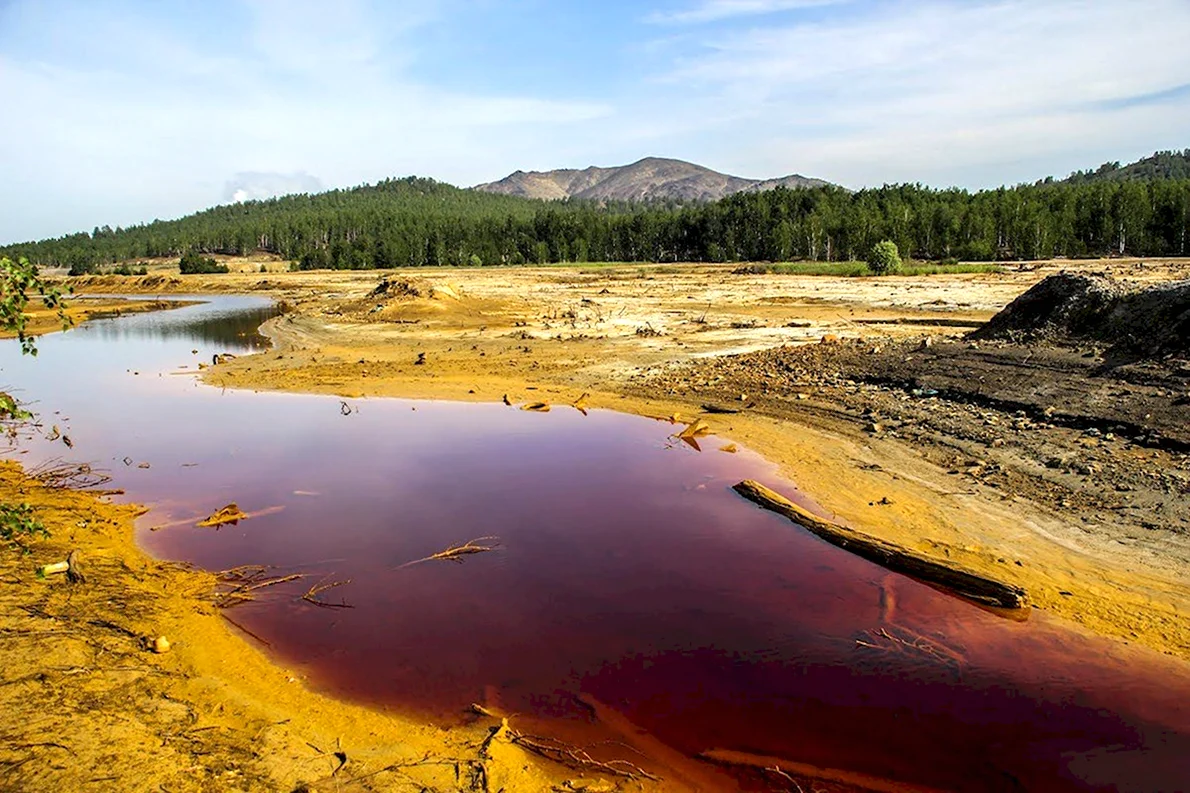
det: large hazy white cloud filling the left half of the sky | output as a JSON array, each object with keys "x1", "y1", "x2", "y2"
[{"x1": 0, "y1": 0, "x2": 613, "y2": 243}]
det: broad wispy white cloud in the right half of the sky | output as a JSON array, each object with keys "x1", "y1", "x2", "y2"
[{"x1": 663, "y1": 0, "x2": 1190, "y2": 185}]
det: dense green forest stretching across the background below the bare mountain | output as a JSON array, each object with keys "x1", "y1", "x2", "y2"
[{"x1": 9, "y1": 152, "x2": 1190, "y2": 274}]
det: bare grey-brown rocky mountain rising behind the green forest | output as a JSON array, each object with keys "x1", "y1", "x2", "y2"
[{"x1": 472, "y1": 157, "x2": 828, "y2": 201}]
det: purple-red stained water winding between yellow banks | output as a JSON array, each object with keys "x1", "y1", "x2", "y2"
[{"x1": 0, "y1": 298, "x2": 1190, "y2": 791}]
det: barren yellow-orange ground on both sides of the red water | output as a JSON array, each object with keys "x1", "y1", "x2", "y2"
[{"x1": 9, "y1": 255, "x2": 1190, "y2": 789}]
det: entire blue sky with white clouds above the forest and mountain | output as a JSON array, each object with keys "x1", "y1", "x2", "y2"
[{"x1": 0, "y1": 0, "x2": 1190, "y2": 244}]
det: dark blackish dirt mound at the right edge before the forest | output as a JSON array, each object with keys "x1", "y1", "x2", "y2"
[{"x1": 970, "y1": 273, "x2": 1190, "y2": 356}]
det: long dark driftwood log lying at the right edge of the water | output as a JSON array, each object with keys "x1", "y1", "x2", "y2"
[{"x1": 733, "y1": 479, "x2": 1026, "y2": 608}]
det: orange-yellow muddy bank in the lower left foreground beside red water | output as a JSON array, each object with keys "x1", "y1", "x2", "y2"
[{"x1": 0, "y1": 461, "x2": 575, "y2": 791}]
